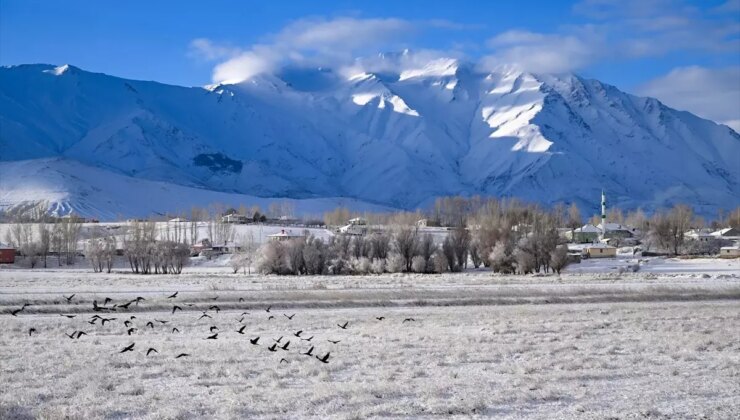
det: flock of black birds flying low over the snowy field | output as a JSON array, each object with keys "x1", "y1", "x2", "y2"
[{"x1": 10, "y1": 292, "x2": 415, "y2": 363}]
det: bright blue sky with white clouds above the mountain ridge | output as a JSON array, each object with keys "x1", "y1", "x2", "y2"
[{"x1": 0, "y1": 0, "x2": 740, "y2": 129}]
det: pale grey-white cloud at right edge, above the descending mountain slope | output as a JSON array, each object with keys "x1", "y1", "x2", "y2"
[{"x1": 637, "y1": 66, "x2": 740, "y2": 132}]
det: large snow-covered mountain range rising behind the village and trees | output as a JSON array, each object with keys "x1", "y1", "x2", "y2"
[{"x1": 0, "y1": 58, "x2": 740, "y2": 220}]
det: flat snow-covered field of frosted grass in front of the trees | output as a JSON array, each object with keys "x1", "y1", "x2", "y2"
[{"x1": 0, "y1": 260, "x2": 740, "y2": 419}]
